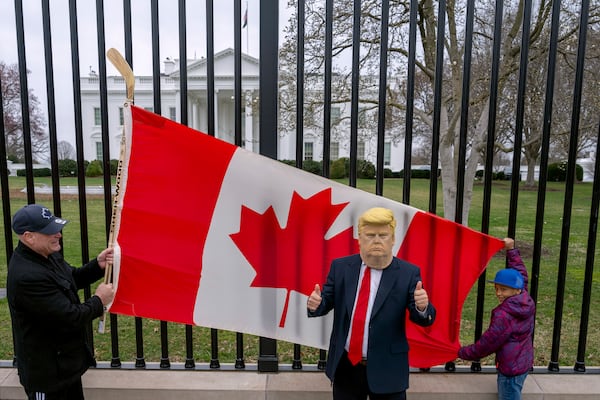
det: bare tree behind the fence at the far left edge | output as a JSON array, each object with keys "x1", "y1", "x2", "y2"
[{"x1": 0, "y1": 61, "x2": 48, "y2": 162}]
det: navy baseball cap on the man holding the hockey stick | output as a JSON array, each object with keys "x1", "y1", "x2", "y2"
[{"x1": 13, "y1": 204, "x2": 69, "y2": 235}]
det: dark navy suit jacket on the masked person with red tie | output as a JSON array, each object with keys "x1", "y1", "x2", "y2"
[{"x1": 308, "y1": 254, "x2": 435, "y2": 393}]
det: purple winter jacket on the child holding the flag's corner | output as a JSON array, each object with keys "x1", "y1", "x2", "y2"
[{"x1": 458, "y1": 249, "x2": 535, "y2": 376}]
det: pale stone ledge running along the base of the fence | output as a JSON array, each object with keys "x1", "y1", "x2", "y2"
[{"x1": 0, "y1": 365, "x2": 600, "y2": 400}]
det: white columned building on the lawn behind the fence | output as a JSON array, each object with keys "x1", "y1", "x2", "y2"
[{"x1": 81, "y1": 49, "x2": 404, "y2": 171}]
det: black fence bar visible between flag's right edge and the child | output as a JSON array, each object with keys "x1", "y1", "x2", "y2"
[{"x1": 471, "y1": 0, "x2": 504, "y2": 372}]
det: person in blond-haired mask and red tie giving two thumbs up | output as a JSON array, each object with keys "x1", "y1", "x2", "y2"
[{"x1": 307, "y1": 207, "x2": 435, "y2": 400}]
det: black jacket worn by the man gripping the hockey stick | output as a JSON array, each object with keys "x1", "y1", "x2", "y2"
[{"x1": 6, "y1": 242, "x2": 104, "y2": 393}]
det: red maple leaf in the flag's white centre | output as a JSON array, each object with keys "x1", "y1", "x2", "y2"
[{"x1": 230, "y1": 188, "x2": 358, "y2": 328}]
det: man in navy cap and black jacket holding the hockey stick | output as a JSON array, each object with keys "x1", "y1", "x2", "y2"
[{"x1": 6, "y1": 204, "x2": 114, "y2": 400}]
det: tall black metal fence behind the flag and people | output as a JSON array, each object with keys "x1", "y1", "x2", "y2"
[{"x1": 0, "y1": 0, "x2": 600, "y2": 372}]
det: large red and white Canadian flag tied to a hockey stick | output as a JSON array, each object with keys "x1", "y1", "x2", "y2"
[{"x1": 110, "y1": 106, "x2": 503, "y2": 368}]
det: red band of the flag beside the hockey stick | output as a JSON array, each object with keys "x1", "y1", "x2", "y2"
[{"x1": 111, "y1": 107, "x2": 235, "y2": 323}]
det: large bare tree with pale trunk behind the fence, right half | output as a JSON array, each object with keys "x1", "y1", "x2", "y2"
[{"x1": 282, "y1": 0, "x2": 592, "y2": 222}]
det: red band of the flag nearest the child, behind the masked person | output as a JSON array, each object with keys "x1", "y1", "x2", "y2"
[{"x1": 398, "y1": 212, "x2": 504, "y2": 368}]
